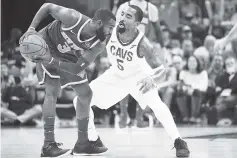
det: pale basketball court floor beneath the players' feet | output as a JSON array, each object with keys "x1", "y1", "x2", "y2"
[{"x1": 1, "y1": 126, "x2": 237, "y2": 158}]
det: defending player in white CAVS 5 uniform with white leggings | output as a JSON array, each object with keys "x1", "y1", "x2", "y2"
[{"x1": 74, "y1": 5, "x2": 189, "y2": 157}]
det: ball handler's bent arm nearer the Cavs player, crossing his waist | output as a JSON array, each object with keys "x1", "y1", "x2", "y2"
[{"x1": 48, "y1": 42, "x2": 105, "y2": 74}]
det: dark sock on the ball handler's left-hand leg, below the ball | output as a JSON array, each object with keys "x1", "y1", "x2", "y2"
[{"x1": 43, "y1": 117, "x2": 55, "y2": 146}]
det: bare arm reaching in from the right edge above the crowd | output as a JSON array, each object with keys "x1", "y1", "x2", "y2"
[{"x1": 214, "y1": 23, "x2": 237, "y2": 53}]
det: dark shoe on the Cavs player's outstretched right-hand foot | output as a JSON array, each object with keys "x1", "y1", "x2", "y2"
[{"x1": 174, "y1": 138, "x2": 190, "y2": 157}]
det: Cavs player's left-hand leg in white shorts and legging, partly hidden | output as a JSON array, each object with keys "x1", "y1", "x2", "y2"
[{"x1": 74, "y1": 69, "x2": 128, "y2": 141}]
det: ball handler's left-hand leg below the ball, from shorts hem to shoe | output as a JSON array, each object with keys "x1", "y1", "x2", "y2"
[{"x1": 36, "y1": 64, "x2": 70, "y2": 157}]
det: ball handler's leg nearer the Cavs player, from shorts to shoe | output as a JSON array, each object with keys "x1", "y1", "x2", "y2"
[{"x1": 59, "y1": 70, "x2": 111, "y2": 155}]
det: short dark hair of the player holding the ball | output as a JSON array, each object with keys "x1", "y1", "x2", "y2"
[{"x1": 92, "y1": 8, "x2": 116, "y2": 23}]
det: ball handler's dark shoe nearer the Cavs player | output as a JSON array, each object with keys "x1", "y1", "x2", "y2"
[{"x1": 72, "y1": 141, "x2": 108, "y2": 156}]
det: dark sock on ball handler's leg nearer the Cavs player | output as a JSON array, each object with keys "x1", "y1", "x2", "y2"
[{"x1": 77, "y1": 117, "x2": 89, "y2": 143}]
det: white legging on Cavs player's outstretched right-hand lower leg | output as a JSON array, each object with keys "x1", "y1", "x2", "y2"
[{"x1": 150, "y1": 101, "x2": 181, "y2": 141}]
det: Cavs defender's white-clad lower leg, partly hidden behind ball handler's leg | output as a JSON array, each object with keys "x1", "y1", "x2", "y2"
[{"x1": 73, "y1": 97, "x2": 99, "y2": 141}]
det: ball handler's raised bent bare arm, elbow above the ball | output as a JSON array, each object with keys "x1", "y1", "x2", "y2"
[{"x1": 30, "y1": 3, "x2": 81, "y2": 28}]
